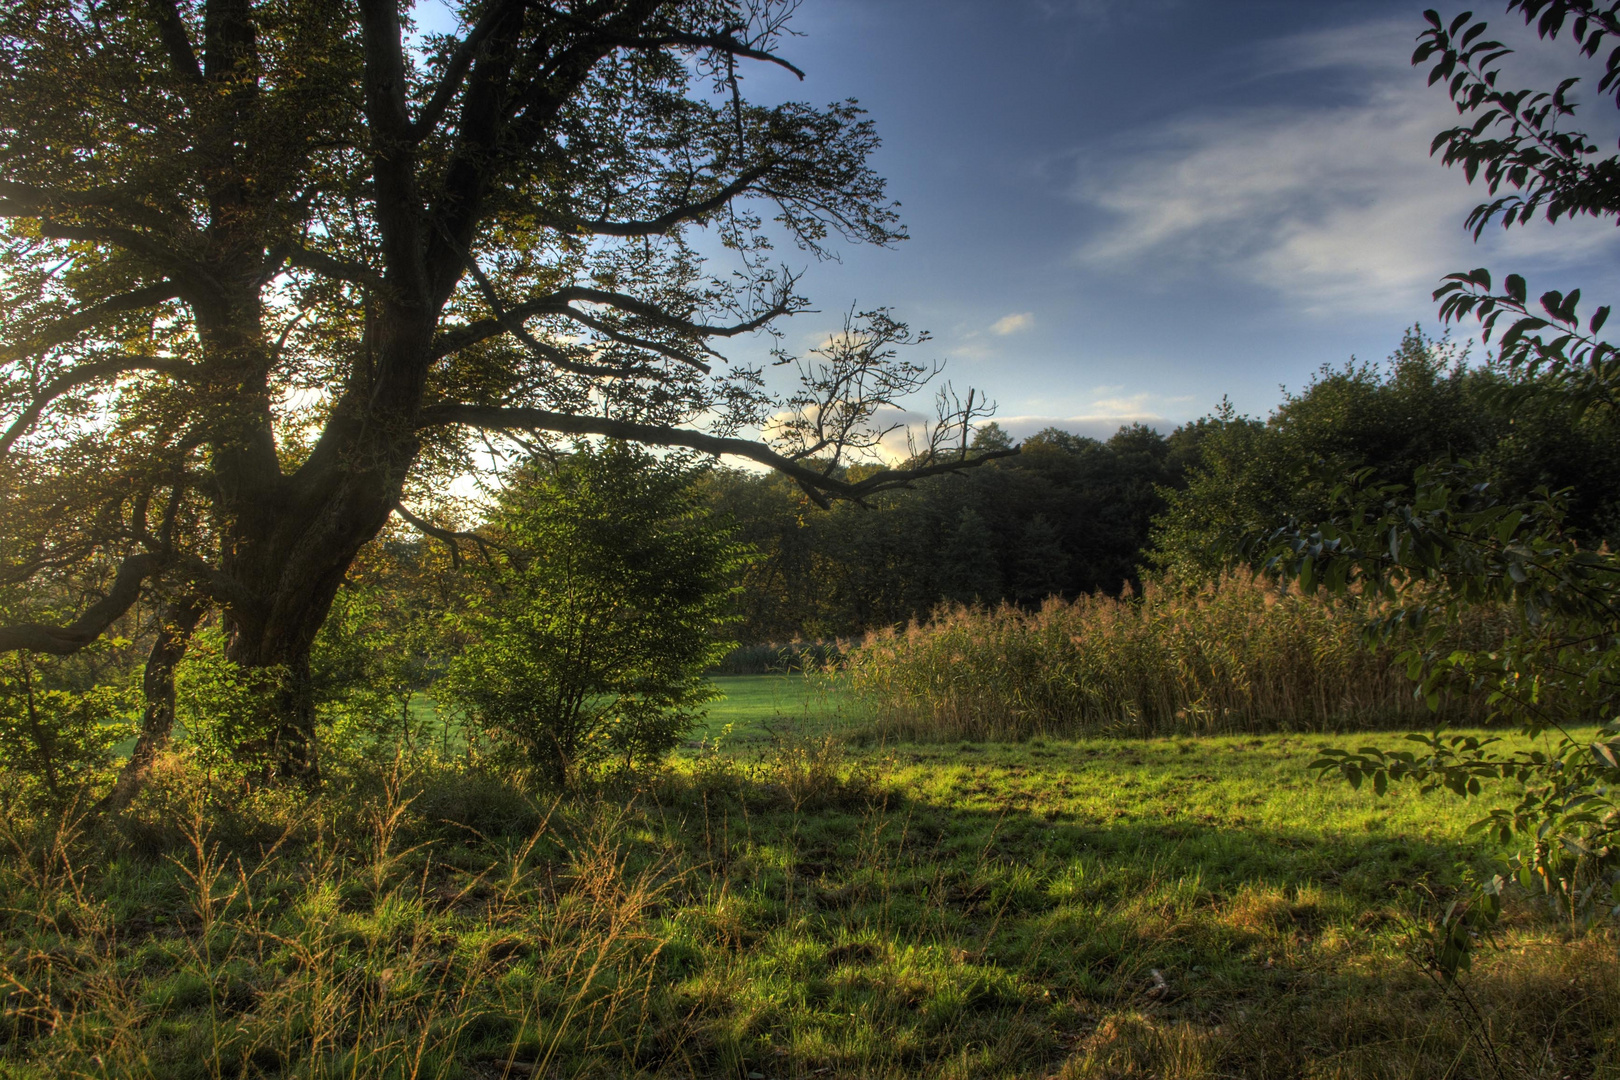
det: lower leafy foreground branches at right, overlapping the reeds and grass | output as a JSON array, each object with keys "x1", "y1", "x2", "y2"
[{"x1": 1251, "y1": 463, "x2": 1620, "y2": 975}]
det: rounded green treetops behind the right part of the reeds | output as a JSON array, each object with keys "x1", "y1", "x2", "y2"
[{"x1": 1153, "y1": 327, "x2": 1620, "y2": 578}]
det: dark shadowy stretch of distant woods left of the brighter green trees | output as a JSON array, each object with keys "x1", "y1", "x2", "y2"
[{"x1": 705, "y1": 424, "x2": 1200, "y2": 641}]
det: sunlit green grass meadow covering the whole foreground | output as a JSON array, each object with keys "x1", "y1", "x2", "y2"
[{"x1": 0, "y1": 677, "x2": 1620, "y2": 1080}]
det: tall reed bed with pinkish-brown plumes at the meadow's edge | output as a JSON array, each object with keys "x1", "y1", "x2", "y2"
[{"x1": 846, "y1": 573, "x2": 1500, "y2": 740}]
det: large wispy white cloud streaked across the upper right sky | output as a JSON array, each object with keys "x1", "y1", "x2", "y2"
[{"x1": 1076, "y1": 23, "x2": 1615, "y2": 313}]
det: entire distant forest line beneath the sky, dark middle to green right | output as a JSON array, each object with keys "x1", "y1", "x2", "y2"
[{"x1": 701, "y1": 329, "x2": 1620, "y2": 643}]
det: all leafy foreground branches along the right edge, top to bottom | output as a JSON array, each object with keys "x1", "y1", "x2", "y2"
[{"x1": 1249, "y1": 0, "x2": 1620, "y2": 978}]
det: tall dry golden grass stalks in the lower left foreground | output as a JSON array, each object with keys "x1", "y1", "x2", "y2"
[{"x1": 0, "y1": 769, "x2": 680, "y2": 1080}]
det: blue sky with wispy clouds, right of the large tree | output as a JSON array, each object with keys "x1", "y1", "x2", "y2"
[{"x1": 424, "y1": 0, "x2": 1620, "y2": 436}]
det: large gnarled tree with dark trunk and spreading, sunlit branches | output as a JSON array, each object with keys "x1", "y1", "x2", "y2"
[{"x1": 0, "y1": 0, "x2": 1004, "y2": 772}]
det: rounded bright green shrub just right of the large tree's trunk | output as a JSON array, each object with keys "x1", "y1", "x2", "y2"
[{"x1": 441, "y1": 444, "x2": 742, "y2": 782}]
